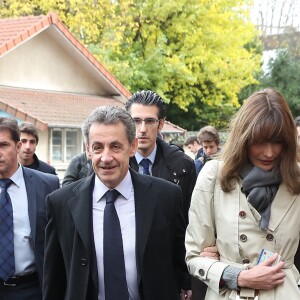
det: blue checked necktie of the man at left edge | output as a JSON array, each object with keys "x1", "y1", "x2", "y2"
[{"x1": 0, "y1": 179, "x2": 15, "y2": 281}]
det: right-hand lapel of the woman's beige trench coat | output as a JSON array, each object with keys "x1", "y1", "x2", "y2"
[{"x1": 269, "y1": 184, "x2": 297, "y2": 231}]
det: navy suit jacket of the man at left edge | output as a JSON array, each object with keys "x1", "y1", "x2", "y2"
[{"x1": 22, "y1": 167, "x2": 59, "y2": 283}]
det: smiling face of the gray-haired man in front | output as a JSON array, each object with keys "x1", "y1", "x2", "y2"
[{"x1": 86, "y1": 122, "x2": 137, "y2": 189}]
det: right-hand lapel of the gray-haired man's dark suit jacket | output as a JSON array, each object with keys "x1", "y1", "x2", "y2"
[{"x1": 130, "y1": 170, "x2": 158, "y2": 283}]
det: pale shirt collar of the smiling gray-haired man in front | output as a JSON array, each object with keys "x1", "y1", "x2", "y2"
[{"x1": 94, "y1": 170, "x2": 132, "y2": 202}]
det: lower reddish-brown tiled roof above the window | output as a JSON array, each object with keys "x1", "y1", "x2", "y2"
[{"x1": 0, "y1": 86, "x2": 124, "y2": 130}]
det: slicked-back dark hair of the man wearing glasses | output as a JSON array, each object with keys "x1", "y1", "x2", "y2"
[{"x1": 125, "y1": 90, "x2": 166, "y2": 119}]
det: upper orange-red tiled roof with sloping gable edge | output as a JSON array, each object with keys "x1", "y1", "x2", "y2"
[{"x1": 0, "y1": 12, "x2": 131, "y2": 98}]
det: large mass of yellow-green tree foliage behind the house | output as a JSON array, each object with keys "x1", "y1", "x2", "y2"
[{"x1": 0, "y1": 0, "x2": 261, "y2": 129}]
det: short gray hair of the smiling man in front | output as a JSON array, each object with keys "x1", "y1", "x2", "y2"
[{"x1": 82, "y1": 105, "x2": 136, "y2": 144}]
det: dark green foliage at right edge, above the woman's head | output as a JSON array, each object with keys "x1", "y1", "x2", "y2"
[{"x1": 261, "y1": 49, "x2": 300, "y2": 117}]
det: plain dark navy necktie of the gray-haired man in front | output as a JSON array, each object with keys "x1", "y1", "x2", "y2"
[{"x1": 103, "y1": 190, "x2": 129, "y2": 300}]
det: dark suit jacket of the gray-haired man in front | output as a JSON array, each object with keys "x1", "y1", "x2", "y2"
[{"x1": 43, "y1": 170, "x2": 187, "y2": 300}]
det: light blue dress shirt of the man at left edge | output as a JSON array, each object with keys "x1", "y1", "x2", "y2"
[{"x1": 5, "y1": 166, "x2": 36, "y2": 276}]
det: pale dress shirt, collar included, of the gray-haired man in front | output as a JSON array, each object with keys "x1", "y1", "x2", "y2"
[{"x1": 93, "y1": 171, "x2": 139, "y2": 300}]
